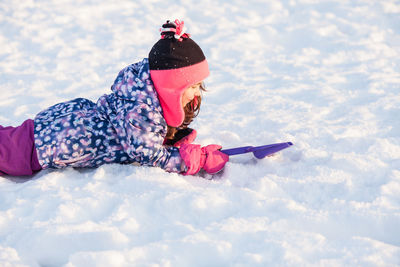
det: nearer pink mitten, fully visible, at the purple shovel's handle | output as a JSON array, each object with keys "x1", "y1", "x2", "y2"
[{"x1": 179, "y1": 144, "x2": 229, "y2": 175}]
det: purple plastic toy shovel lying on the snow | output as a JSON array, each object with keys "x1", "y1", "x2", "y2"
[{"x1": 221, "y1": 142, "x2": 293, "y2": 159}]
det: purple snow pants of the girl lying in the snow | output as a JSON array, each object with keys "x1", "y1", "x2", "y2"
[{"x1": 0, "y1": 120, "x2": 42, "y2": 176}]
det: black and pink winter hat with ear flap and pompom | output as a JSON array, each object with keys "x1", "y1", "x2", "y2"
[{"x1": 149, "y1": 20, "x2": 210, "y2": 127}]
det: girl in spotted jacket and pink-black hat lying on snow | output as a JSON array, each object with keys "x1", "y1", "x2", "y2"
[{"x1": 0, "y1": 20, "x2": 229, "y2": 178}]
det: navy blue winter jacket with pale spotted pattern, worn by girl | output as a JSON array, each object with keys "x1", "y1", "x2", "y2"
[{"x1": 34, "y1": 59, "x2": 182, "y2": 172}]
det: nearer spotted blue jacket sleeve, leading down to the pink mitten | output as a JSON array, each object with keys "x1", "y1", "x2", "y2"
[{"x1": 117, "y1": 103, "x2": 183, "y2": 173}]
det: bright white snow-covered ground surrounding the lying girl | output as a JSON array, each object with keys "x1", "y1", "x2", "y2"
[{"x1": 0, "y1": 0, "x2": 400, "y2": 267}]
